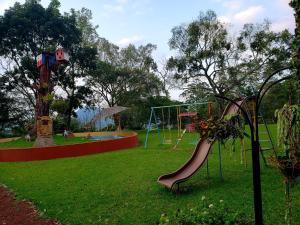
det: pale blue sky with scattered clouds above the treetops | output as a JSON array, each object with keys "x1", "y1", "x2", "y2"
[{"x1": 0, "y1": 0, "x2": 295, "y2": 99}]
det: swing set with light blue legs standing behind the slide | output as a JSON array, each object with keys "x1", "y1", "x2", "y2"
[{"x1": 144, "y1": 102, "x2": 212, "y2": 149}]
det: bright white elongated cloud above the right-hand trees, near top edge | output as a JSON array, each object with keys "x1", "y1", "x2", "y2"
[{"x1": 233, "y1": 5, "x2": 264, "y2": 24}]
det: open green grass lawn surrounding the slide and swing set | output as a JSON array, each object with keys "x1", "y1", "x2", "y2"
[{"x1": 0, "y1": 127, "x2": 300, "y2": 225}]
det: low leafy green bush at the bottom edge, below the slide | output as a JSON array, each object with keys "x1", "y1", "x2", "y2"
[{"x1": 159, "y1": 196, "x2": 254, "y2": 225}]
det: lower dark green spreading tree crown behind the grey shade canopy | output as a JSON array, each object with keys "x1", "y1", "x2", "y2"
[{"x1": 88, "y1": 62, "x2": 161, "y2": 107}]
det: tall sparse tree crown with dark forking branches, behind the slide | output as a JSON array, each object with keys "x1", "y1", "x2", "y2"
[{"x1": 168, "y1": 11, "x2": 242, "y2": 108}]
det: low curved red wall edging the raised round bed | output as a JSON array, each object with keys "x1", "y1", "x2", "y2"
[{"x1": 0, "y1": 133, "x2": 138, "y2": 162}]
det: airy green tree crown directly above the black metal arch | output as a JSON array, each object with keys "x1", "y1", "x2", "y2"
[{"x1": 237, "y1": 20, "x2": 293, "y2": 92}]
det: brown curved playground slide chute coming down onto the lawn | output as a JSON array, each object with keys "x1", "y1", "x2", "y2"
[{"x1": 157, "y1": 98, "x2": 245, "y2": 189}]
